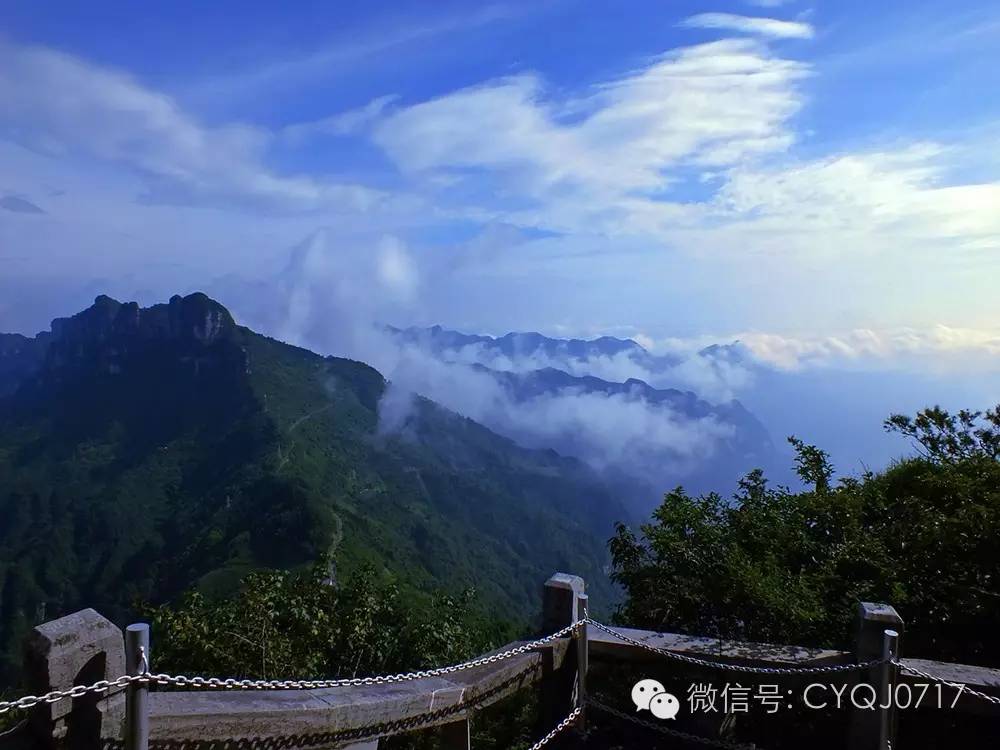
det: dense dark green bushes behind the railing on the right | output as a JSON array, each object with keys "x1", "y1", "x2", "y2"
[{"x1": 611, "y1": 408, "x2": 1000, "y2": 665}]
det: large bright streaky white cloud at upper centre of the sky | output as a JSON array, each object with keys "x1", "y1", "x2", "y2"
[{"x1": 374, "y1": 39, "x2": 809, "y2": 233}]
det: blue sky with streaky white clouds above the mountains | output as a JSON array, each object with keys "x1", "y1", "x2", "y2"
[{"x1": 0, "y1": 0, "x2": 1000, "y2": 376}]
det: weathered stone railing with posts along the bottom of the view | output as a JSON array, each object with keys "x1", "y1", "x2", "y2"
[{"x1": 0, "y1": 573, "x2": 1000, "y2": 750}]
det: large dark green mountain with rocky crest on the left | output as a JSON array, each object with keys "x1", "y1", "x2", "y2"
[{"x1": 0, "y1": 294, "x2": 626, "y2": 680}]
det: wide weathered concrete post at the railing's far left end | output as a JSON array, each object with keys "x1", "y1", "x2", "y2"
[{"x1": 24, "y1": 609, "x2": 125, "y2": 748}]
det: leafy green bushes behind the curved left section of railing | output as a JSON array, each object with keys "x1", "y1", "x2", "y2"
[{"x1": 141, "y1": 559, "x2": 538, "y2": 750}]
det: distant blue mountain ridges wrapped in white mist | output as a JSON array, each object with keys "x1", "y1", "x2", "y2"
[{"x1": 390, "y1": 326, "x2": 785, "y2": 514}]
